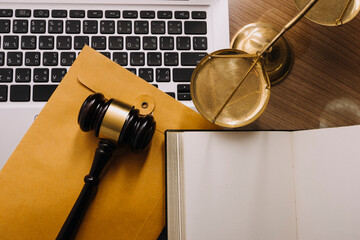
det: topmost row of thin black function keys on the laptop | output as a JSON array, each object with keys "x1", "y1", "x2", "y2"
[{"x1": 0, "y1": 9, "x2": 206, "y2": 19}]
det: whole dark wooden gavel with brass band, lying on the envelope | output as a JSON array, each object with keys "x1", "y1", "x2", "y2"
[{"x1": 56, "y1": 93, "x2": 156, "y2": 240}]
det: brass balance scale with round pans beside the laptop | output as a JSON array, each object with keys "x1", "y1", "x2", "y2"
[{"x1": 190, "y1": 0, "x2": 360, "y2": 128}]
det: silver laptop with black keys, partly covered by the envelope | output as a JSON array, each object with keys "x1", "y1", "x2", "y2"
[{"x1": 0, "y1": 0, "x2": 229, "y2": 169}]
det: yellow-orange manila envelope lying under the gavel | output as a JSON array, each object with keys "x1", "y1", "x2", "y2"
[{"x1": 0, "y1": 46, "x2": 215, "y2": 240}]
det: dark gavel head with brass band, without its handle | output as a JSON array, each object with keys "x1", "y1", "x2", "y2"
[{"x1": 78, "y1": 93, "x2": 156, "y2": 151}]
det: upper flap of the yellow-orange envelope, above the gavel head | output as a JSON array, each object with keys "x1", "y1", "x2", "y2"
[{"x1": 77, "y1": 46, "x2": 215, "y2": 132}]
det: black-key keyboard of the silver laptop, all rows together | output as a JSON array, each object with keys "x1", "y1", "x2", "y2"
[{"x1": 0, "y1": 9, "x2": 208, "y2": 102}]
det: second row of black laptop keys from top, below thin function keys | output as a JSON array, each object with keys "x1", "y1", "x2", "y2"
[{"x1": 0, "y1": 19, "x2": 207, "y2": 35}]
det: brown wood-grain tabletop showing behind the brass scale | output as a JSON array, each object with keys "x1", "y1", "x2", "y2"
[{"x1": 229, "y1": 0, "x2": 360, "y2": 130}]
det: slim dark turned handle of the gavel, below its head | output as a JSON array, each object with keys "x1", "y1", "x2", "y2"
[{"x1": 56, "y1": 140, "x2": 115, "y2": 240}]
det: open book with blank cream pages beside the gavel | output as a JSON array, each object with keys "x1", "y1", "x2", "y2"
[{"x1": 166, "y1": 126, "x2": 360, "y2": 240}]
